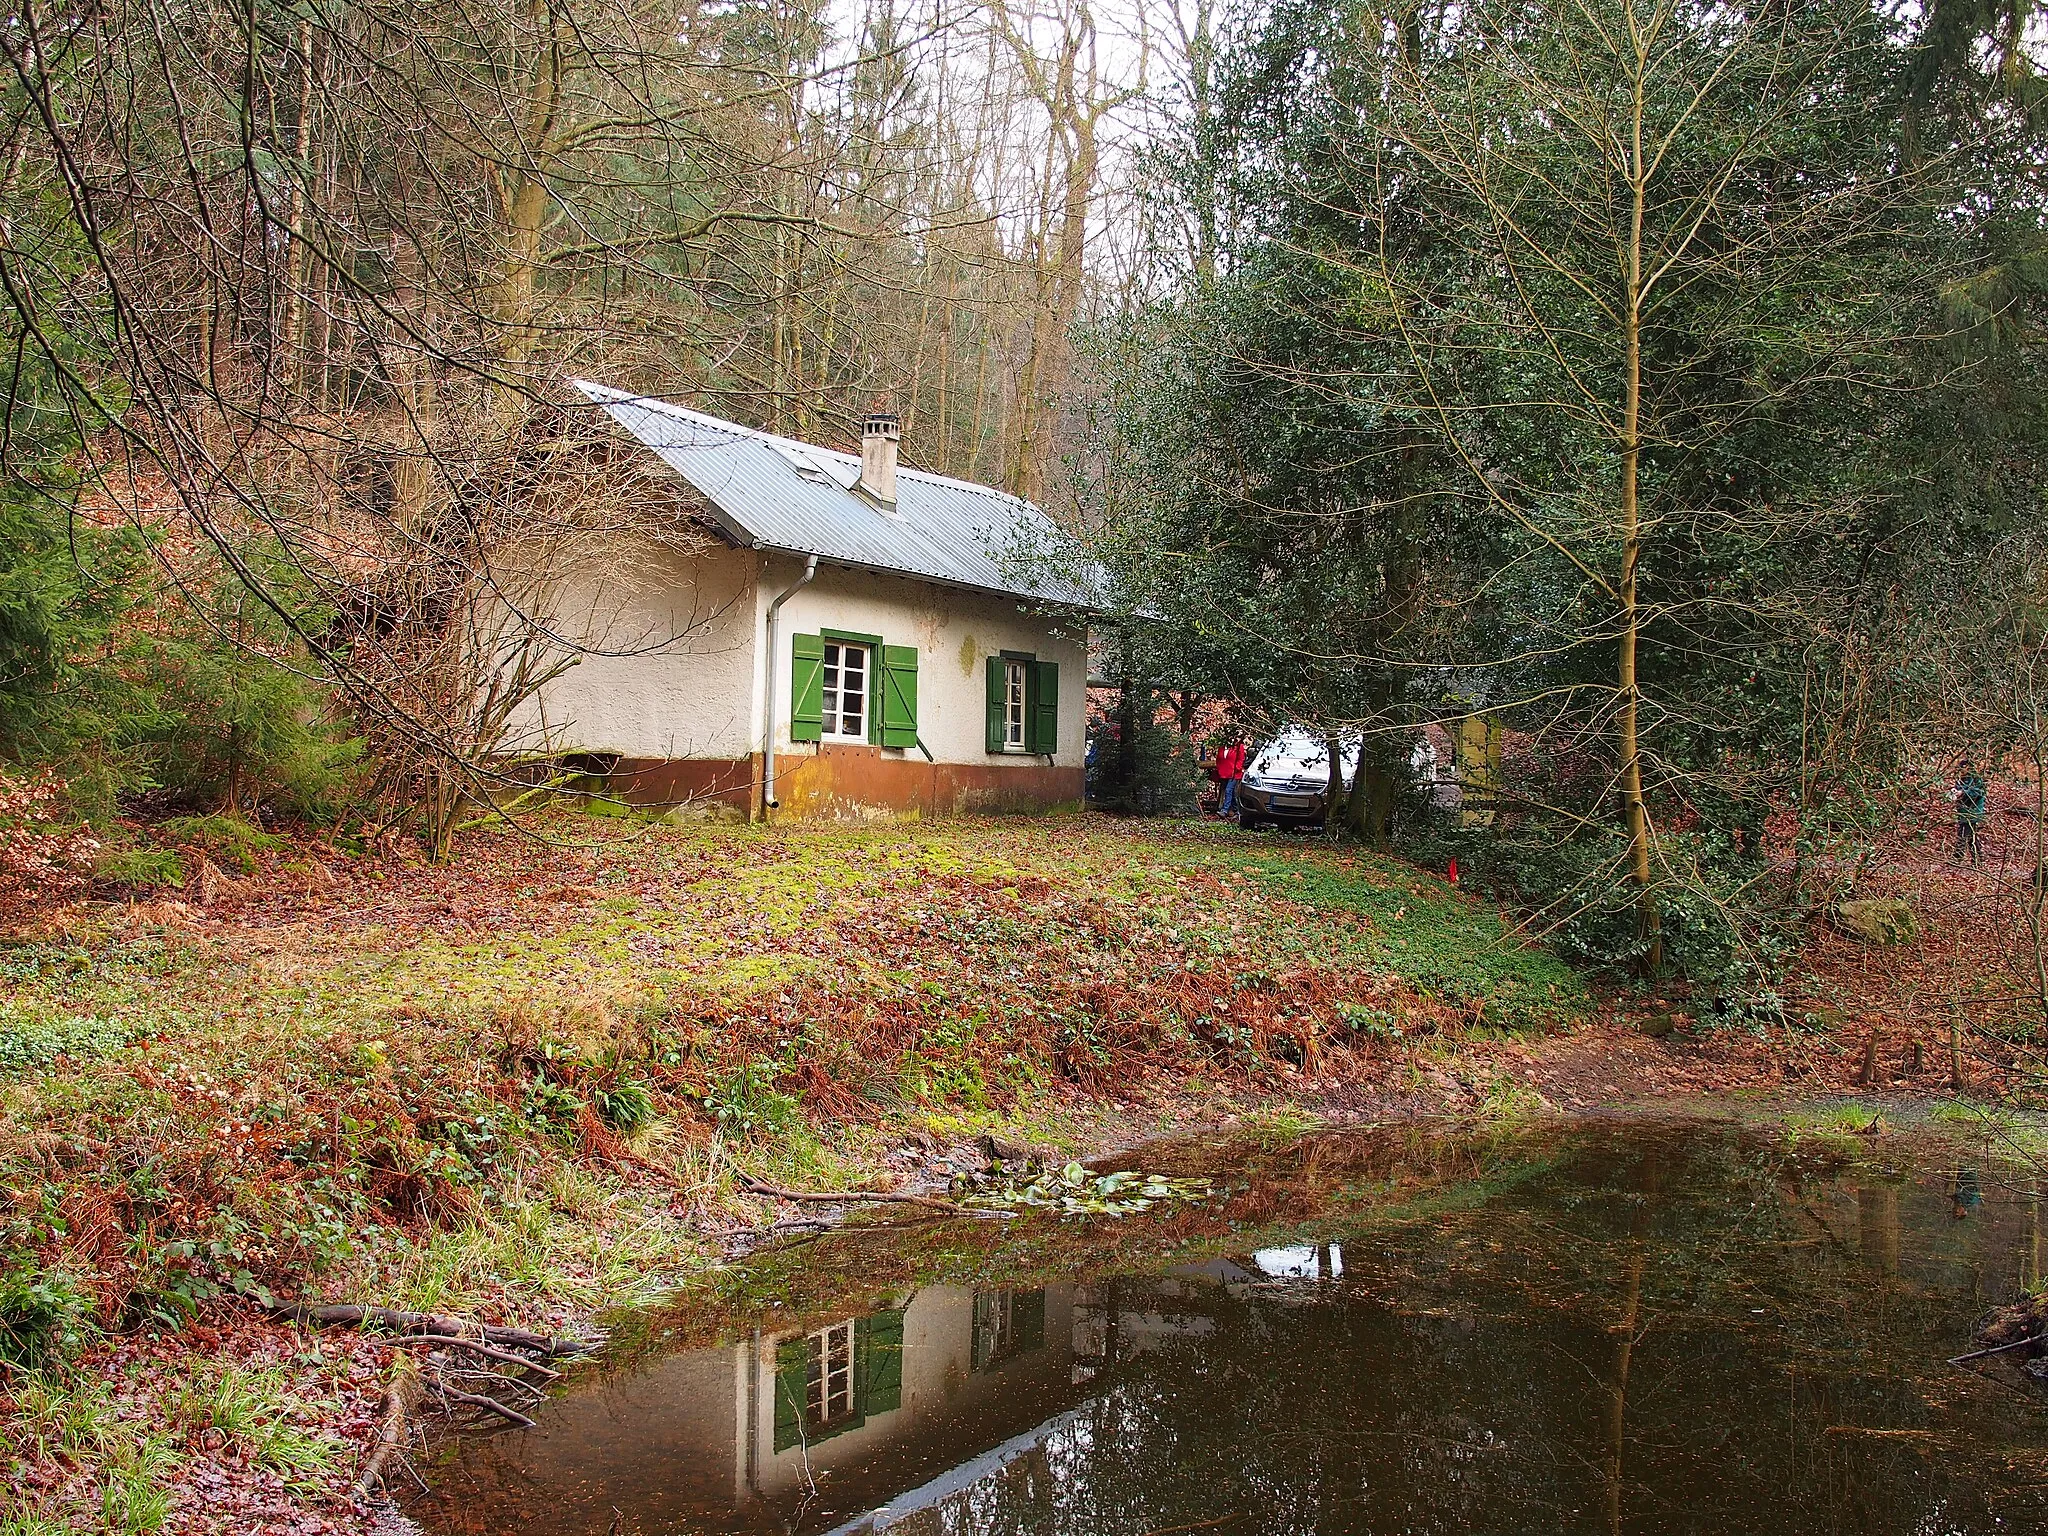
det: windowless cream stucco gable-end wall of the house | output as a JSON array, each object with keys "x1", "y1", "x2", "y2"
[{"x1": 514, "y1": 545, "x2": 760, "y2": 760}]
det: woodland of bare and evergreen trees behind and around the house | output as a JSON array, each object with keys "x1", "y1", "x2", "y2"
[{"x1": 0, "y1": 0, "x2": 2048, "y2": 1014}]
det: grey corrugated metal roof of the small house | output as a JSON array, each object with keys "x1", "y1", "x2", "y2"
[{"x1": 571, "y1": 379, "x2": 1100, "y2": 608}]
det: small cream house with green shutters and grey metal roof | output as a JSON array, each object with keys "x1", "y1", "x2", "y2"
[{"x1": 514, "y1": 383, "x2": 1090, "y2": 817}]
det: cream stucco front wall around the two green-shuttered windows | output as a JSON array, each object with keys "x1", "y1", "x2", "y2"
[{"x1": 760, "y1": 555, "x2": 1087, "y2": 768}]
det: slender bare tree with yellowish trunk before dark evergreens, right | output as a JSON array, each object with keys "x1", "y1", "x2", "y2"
[{"x1": 1374, "y1": 0, "x2": 1941, "y2": 969}]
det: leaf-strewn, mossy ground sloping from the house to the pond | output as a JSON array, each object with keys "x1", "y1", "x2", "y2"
[{"x1": 0, "y1": 807, "x2": 2040, "y2": 1536}]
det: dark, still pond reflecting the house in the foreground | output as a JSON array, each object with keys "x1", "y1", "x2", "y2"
[{"x1": 412, "y1": 1124, "x2": 2048, "y2": 1536}]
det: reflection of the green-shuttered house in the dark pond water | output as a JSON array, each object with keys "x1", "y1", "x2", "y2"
[{"x1": 423, "y1": 1249, "x2": 1302, "y2": 1536}]
